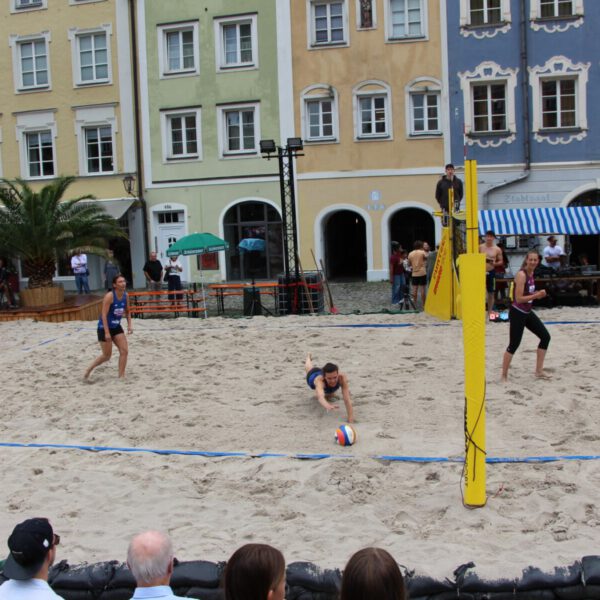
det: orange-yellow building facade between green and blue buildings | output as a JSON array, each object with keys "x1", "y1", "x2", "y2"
[{"x1": 291, "y1": 0, "x2": 448, "y2": 281}]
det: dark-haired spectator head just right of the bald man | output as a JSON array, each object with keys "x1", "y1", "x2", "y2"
[{"x1": 223, "y1": 544, "x2": 285, "y2": 600}]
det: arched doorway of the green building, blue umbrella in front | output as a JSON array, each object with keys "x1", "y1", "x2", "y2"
[{"x1": 223, "y1": 201, "x2": 283, "y2": 281}]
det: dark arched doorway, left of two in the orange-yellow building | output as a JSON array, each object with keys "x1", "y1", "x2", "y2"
[{"x1": 324, "y1": 210, "x2": 367, "y2": 281}]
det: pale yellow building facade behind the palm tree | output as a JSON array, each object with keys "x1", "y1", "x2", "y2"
[{"x1": 0, "y1": 0, "x2": 143, "y2": 288}]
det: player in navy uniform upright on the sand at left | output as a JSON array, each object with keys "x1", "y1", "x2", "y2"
[{"x1": 83, "y1": 275, "x2": 133, "y2": 379}]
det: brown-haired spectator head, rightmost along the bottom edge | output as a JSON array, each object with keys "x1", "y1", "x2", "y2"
[{"x1": 340, "y1": 548, "x2": 406, "y2": 600}]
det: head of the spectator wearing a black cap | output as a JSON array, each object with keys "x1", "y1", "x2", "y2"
[{"x1": 4, "y1": 518, "x2": 60, "y2": 580}]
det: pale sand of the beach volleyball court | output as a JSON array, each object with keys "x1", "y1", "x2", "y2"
[{"x1": 0, "y1": 308, "x2": 600, "y2": 577}]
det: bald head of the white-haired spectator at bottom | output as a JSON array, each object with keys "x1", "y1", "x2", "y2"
[{"x1": 127, "y1": 531, "x2": 173, "y2": 587}]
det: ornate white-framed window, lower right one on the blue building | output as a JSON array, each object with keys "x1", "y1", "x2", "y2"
[{"x1": 529, "y1": 56, "x2": 591, "y2": 143}]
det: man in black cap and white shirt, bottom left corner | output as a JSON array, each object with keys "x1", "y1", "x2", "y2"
[{"x1": 0, "y1": 518, "x2": 61, "y2": 600}]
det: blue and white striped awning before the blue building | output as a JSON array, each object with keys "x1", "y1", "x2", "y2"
[{"x1": 479, "y1": 206, "x2": 600, "y2": 235}]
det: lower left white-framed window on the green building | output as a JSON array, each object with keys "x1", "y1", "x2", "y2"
[{"x1": 161, "y1": 107, "x2": 202, "y2": 161}]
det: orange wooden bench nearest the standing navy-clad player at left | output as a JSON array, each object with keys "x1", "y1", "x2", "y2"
[{"x1": 128, "y1": 290, "x2": 206, "y2": 318}]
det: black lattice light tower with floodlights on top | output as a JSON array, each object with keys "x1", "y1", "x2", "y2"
[{"x1": 260, "y1": 137, "x2": 304, "y2": 312}]
